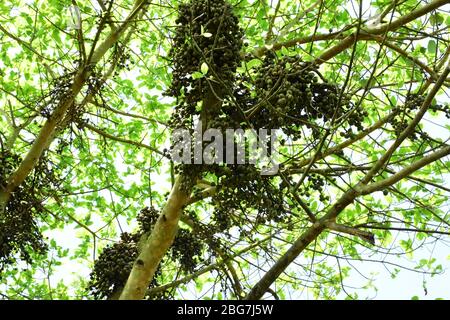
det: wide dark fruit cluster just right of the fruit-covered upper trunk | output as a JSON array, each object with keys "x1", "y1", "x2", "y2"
[{"x1": 246, "y1": 54, "x2": 368, "y2": 139}]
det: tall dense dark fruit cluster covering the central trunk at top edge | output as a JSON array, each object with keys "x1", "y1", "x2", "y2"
[{"x1": 167, "y1": 0, "x2": 243, "y2": 127}]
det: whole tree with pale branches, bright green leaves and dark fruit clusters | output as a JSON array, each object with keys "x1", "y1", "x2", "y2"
[{"x1": 0, "y1": 0, "x2": 450, "y2": 299}]
